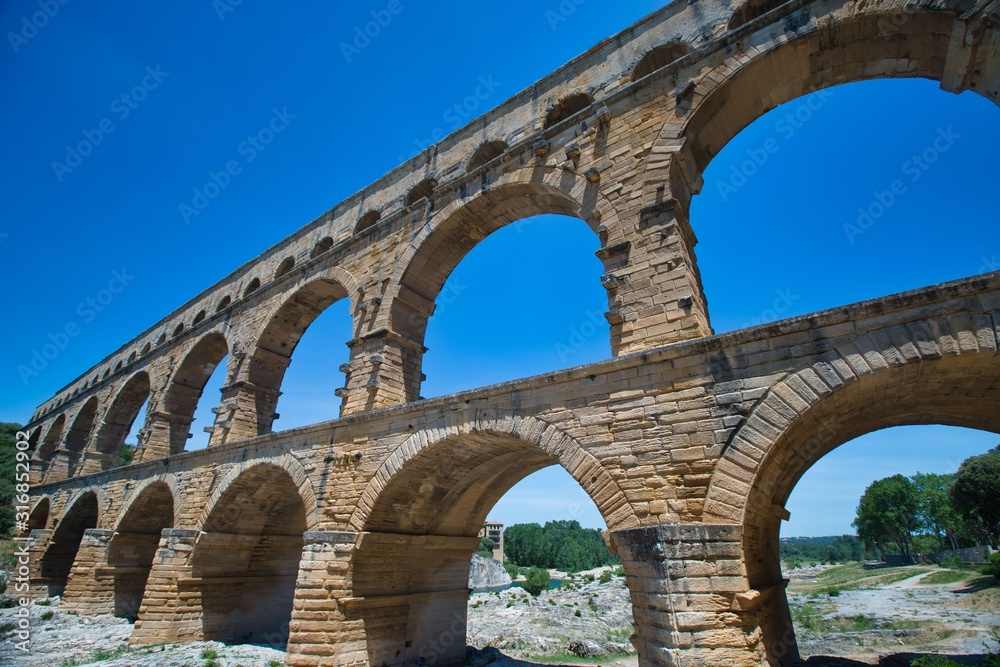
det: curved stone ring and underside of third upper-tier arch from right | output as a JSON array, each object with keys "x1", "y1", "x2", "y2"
[{"x1": 243, "y1": 268, "x2": 357, "y2": 435}]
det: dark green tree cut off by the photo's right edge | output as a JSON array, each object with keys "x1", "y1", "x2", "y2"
[{"x1": 949, "y1": 446, "x2": 1000, "y2": 547}]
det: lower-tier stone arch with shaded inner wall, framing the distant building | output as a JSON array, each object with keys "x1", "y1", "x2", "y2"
[{"x1": 345, "y1": 414, "x2": 638, "y2": 665}]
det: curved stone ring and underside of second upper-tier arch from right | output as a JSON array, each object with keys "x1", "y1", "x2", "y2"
[{"x1": 380, "y1": 169, "x2": 621, "y2": 401}]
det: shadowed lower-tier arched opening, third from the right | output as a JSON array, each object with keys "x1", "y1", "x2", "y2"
[{"x1": 191, "y1": 464, "x2": 306, "y2": 648}]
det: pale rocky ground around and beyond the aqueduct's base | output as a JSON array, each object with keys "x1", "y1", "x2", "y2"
[{"x1": 0, "y1": 568, "x2": 1000, "y2": 667}]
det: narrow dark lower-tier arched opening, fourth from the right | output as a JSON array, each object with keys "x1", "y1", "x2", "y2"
[{"x1": 108, "y1": 482, "x2": 174, "y2": 623}]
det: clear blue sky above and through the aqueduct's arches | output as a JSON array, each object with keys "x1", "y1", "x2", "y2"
[{"x1": 0, "y1": 0, "x2": 1000, "y2": 535}]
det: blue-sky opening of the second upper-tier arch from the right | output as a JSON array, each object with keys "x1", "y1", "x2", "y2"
[{"x1": 422, "y1": 215, "x2": 611, "y2": 397}]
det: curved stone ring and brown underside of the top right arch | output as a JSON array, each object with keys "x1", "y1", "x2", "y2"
[{"x1": 664, "y1": 8, "x2": 996, "y2": 182}]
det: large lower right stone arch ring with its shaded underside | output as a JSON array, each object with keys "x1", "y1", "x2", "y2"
[{"x1": 705, "y1": 317, "x2": 1000, "y2": 665}]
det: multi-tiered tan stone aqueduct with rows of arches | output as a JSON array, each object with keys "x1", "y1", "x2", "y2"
[{"x1": 17, "y1": 0, "x2": 1000, "y2": 666}]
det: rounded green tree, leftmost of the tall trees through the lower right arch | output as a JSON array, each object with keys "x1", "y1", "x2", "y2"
[{"x1": 853, "y1": 475, "x2": 919, "y2": 561}]
